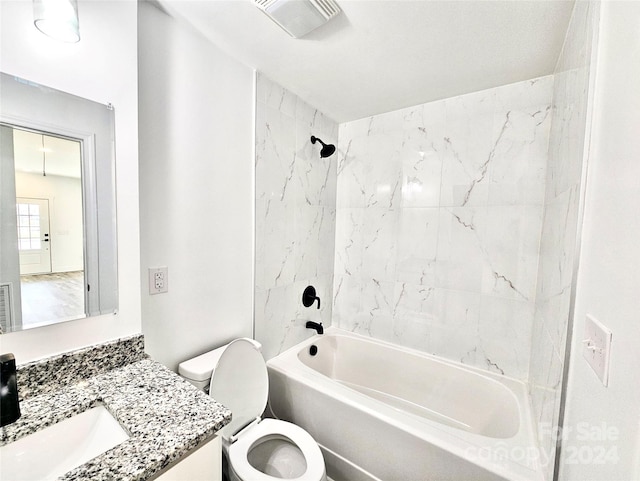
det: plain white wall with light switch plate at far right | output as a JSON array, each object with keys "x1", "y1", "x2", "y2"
[{"x1": 560, "y1": 2, "x2": 640, "y2": 481}]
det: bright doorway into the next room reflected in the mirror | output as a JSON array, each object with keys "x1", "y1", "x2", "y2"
[{"x1": 13, "y1": 128, "x2": 86, "y2": 329}]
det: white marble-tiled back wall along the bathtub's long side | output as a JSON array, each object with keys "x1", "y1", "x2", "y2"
[{"x1": 333, "y1": 76, "x2": 553, "y2": 379}]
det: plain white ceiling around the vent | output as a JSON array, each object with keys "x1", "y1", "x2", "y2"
[{"x1": 158, "y1": 0, "x2": 574, "y2": 122}]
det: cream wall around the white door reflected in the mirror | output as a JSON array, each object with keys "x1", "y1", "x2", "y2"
[{"x1": 16, "y1": 172, "x2": 84, "y2": 272}]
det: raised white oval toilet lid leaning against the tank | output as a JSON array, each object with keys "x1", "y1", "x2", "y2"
[{"x1": 209, "y1": 339, "x2": 269, "y2": 439}]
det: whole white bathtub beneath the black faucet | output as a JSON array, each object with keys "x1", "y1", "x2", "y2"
[{"x1": 267, "y1": 328, "x2": 543, "y2": 481}]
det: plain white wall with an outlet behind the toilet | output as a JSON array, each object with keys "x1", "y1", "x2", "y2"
[{"x1": 138, "y1": 2, "x2": 254, "y2": 369}]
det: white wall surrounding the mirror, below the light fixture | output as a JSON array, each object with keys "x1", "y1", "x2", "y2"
[{"x1": 0, "y1": 0, "x2": 141, "y2": 363}]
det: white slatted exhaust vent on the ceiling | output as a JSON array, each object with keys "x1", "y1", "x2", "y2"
[{"x1": 254, "y1": 0, "x2": 341, "y2": 38}]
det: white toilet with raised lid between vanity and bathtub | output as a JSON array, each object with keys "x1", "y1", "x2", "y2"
[{"x1": 178, "y1": 338, "x2": 327, "y2": 481}]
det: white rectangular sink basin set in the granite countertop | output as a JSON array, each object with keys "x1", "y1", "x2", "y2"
[{"x1": 0, "y1": 406, "x2": 129, "y2": 481}]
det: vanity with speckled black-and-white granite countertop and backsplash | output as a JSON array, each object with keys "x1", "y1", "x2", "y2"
[{"x1": 0, "y1": 335, "x2": 231, "y2": 481}]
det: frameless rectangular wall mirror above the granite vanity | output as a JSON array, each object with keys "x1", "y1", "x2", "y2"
[{"x1": 0, "y1": 73, "x2": 118, "y2": 333}]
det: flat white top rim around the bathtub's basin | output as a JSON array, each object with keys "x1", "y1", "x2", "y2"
[{"x1": 267, "y1": 326, "x2": 543, "y2": 481}]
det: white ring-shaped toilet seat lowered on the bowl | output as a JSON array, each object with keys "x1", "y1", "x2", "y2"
[{"x1": 228, "y1": 419, "x2": 325, "y2": 481}]
